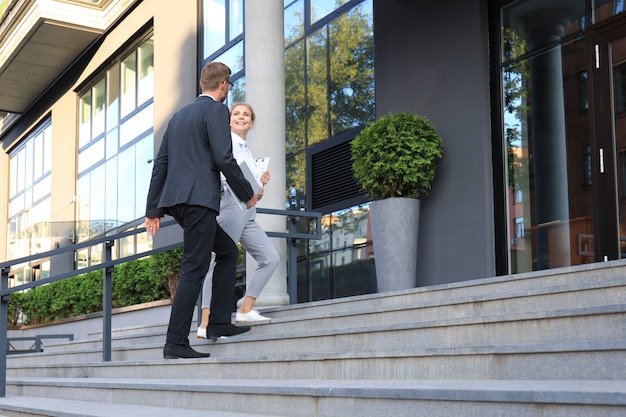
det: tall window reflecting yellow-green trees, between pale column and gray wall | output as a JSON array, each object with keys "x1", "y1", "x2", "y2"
[{"x1": 285, "y1": 0, "x2": 376, "y2": 302}]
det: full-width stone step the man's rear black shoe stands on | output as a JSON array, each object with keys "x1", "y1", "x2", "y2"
[{"x1": 7, "y1": 339, "x2": 626, "y2": 380}]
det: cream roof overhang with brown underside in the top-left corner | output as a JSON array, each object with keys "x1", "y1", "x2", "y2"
[{"x1": 0, "y1": 0, "x2": 136, "y2": 113}]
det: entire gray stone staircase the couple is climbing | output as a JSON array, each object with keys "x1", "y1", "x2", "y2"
[{"x1": 0, "y1": 261, "x2": 626, "y2": 417}]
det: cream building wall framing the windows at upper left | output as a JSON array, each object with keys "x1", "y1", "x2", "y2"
[{"x1": 0, "y1": 0, "x2": 198, "y2": 264}]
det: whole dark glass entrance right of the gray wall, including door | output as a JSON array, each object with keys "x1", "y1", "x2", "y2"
[{"x1": 501, "y1": 0, "x2": 626, "y2": 273}]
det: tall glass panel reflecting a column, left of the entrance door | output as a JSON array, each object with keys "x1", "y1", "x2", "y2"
[{"x1": 501, "y1": 0, "x2": 596, "y2": 273}]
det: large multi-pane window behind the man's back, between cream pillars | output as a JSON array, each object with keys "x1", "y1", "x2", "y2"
[{"x1": 76, "y1": 38, "x2": 154, "y2": 267}]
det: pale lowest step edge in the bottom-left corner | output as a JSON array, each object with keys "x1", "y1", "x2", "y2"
[{"x1": 0, "y1": 396, "x2": 277, "y2": 417}]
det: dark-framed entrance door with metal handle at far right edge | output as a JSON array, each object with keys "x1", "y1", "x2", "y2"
[{"x1": 589, "y1": 18, "x2": 626, "y2": 261}]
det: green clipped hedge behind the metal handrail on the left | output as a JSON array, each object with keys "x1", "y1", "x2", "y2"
[{"x1": 8, "y1": 248, "x2": 182, "y2": 326}]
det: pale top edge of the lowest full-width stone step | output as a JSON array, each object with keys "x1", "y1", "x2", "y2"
[{"x1": 0, "y1": 378, "x2": 626, "y2": 406}]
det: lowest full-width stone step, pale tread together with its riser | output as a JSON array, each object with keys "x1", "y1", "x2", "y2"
[{"x1": 0, "y1": 378, "x2": 626, "y2": 417}]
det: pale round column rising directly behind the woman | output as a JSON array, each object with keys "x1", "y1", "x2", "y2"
[{"x1": 244, "y1": 0, "x2": 289, "y2": 308}]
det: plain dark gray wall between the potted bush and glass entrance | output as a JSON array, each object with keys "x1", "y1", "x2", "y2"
[{"x1": 374, "y1": 0, "x2": 495, "y2": 286}]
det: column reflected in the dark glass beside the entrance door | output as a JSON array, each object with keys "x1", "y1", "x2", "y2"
[{"x1": 523, "y1": 9, "x2": 571, "y2": 269}]
